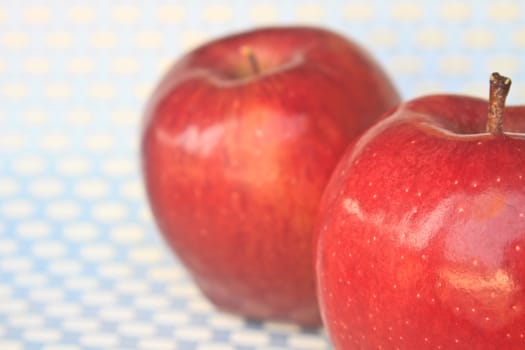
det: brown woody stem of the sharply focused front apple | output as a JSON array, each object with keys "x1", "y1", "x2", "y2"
[{"x1": 486, "y1": 73, "x2": 511, "y2": 135}]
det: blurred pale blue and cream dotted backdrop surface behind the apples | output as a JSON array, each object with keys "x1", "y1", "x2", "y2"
[{"x1": 0, "y1": 0, "x2": 525, "y2": 350}]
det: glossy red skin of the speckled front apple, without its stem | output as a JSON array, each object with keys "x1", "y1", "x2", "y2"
[{"x1": 316, "y1": 95, "x2": 525, "y2": 350}]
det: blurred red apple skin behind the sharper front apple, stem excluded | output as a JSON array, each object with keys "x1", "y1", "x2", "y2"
[{"x1": 142, "y1": 27, "x2": 399, "y2": 326}]
